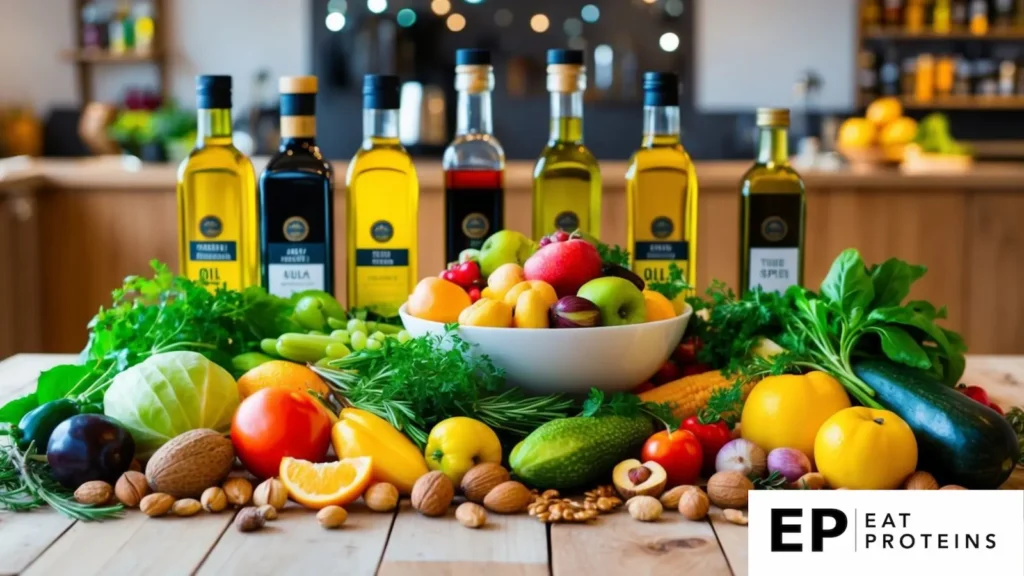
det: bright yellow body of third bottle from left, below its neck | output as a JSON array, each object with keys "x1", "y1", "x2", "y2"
[{"x1": 348, "y1": 170, "x2": 417, "y2": 316}]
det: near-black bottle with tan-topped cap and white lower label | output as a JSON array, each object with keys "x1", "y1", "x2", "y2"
[{"x1": 259, "y1": 76, "x2": 334, "y2": 297}]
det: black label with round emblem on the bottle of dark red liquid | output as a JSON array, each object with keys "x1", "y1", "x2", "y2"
[{"x1": 444, "y1": 183, "x2": 505, "y2": 262}]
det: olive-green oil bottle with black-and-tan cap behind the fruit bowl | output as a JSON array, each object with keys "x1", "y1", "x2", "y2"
[{"x1": 534, "y1": 50, "x2": 601, "y2": 240}]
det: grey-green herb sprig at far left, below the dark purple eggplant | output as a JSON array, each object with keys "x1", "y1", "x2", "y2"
[{"x1": 0, "y1": 442, "x2": 124, "y2": 522}]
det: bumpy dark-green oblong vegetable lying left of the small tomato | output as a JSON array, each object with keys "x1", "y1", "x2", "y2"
[{"x1": 509, "y1": 416, "x2": 653, "y2": 490}]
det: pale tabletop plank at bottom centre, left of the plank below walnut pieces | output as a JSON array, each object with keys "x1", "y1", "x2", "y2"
[{"x1": 380, "y1": 502, "x2": 548, "y2": 576}]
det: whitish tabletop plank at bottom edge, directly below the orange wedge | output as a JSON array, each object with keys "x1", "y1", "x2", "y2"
[{"x1": 199, "y1": 501, "x2": 395, "y2": 576}]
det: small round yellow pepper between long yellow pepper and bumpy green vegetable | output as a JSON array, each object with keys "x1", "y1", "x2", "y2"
[{"x1": 424, "y1": 416, "x2": 502, "y2": 486}]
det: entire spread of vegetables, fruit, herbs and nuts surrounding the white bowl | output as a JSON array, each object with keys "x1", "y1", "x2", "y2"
[{"x1": 0, "y1": 245, "x2": 1024, "y2": 531}]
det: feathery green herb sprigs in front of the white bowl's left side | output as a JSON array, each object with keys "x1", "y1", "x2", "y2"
[{"x1": 313, "y1": 325, "x2": 573, "y2": 448}]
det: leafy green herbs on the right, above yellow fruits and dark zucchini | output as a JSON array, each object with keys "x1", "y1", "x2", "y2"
[{"x1": 695, "y1": 249, "x2": 967, "y2": 408}]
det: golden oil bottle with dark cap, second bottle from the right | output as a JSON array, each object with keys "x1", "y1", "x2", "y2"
[{"x1": 626, "y1": 72, "x2": 697, "y2": 293}]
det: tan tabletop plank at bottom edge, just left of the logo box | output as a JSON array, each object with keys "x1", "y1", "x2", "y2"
[{"x1": 551, "y1": 508, "x2": 730, "y2": 576}]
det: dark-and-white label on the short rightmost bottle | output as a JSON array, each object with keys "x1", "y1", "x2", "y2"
[{"x1": 746, "y1": 194, "x2": 803, "y2": 293}]
